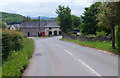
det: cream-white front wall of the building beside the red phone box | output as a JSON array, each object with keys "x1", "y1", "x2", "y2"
[{"x1": 45, "y1": 27, "x2": 60, "y2": 36}]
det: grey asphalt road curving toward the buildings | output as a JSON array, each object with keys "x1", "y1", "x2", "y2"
[{"x1": 23, "y1": 36, "x2": 118, "y2": 76}]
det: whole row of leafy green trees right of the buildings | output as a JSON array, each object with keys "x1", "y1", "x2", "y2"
[{"x1": 56, "y1": 2, "x2": 120, "y2": 49}]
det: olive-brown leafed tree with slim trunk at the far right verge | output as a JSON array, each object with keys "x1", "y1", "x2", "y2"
[{"x1": 98, "y1": 2, "x2": 120, "y2": 49}]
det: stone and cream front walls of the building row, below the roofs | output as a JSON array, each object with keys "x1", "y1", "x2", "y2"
[{"x1": 21, "y1": 27, "x2": 60, "y2": 37}]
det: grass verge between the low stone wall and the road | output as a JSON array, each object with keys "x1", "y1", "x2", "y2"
[{"x1": 61, "y1": 39, "x2": 120, "y2": 55}]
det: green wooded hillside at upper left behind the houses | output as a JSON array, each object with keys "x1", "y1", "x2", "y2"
[{"x1": 0, "y1": 12, "x2": 25, "y2": 24}]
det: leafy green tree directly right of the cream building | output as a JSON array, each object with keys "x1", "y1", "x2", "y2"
[{"x1": 56, "y1": 5, "x2": 72, "y2": 33}]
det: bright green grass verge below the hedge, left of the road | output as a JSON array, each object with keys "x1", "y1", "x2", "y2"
[{"x1": 2, "y1": 38, "x2": 34, "y2": 78}]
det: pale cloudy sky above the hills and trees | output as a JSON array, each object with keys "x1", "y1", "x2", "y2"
[{"x1": 0, "y1": 0, "x2": 92, "y2": 17}]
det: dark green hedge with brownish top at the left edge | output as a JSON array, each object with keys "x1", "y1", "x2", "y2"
[{"x1": 2, "y1": 30, "x2": 24, "y2": 60}]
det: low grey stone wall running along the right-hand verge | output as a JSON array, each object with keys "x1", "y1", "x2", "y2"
[{"x1": 63, "y1": 35, "x2": 111, "y2": 41}]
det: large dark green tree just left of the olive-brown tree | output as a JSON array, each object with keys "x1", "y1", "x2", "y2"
[{"x1": 80, "y1": 2, "x2": 101, "y2": 35}]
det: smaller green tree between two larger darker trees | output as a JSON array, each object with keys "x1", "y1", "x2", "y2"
[{"x1": 72, "y1": 15, "x2": 81, "y2": 29}]
